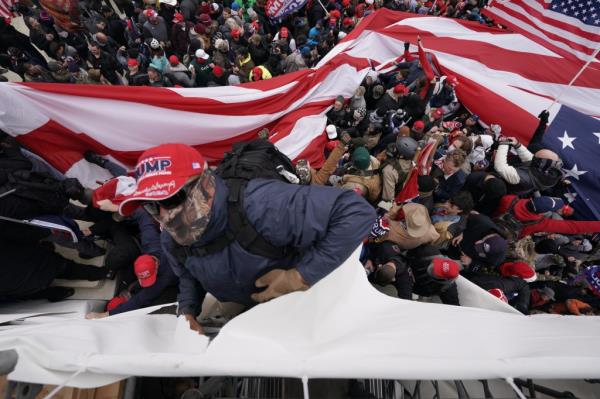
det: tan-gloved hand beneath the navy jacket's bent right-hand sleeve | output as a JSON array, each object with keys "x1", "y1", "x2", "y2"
[{"x1": 251, "y1": 268, "x2": 309, "y2": 302}]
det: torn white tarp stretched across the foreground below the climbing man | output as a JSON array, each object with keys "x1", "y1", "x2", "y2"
[{"x1": 0, "y1": 250, "x2": 600, "y2": 387}]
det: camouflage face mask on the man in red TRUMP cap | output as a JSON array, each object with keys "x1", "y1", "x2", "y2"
[{"x1": 155, "y1": 171, "x2": 216, "y2": 245}]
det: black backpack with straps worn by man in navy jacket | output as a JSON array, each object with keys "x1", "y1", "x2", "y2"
[{"x1": 174, "y1": 139, "x2": 296, "y2": 263}]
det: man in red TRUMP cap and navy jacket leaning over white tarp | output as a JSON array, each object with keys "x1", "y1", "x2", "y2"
[{"x1": 119, "y1": 144, "x2": 375, "y2": 332}]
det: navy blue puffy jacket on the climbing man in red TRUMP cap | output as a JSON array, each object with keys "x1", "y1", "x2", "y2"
[{"x1": 162, "y1": 177, "x2": 375, "y2": 315}]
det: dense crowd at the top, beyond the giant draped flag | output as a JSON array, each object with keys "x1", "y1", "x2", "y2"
[{"x1": 0, "y1": 0, "x2": 489, "y2": 87}]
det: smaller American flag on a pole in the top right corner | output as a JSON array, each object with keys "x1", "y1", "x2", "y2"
[{"x1": 483, "y1": 0, "x2": 600, "y2": 61}]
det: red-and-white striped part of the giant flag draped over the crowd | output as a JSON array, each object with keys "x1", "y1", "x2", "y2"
[{"x1": 0, "y1": 9, "x2": 600, "y2": 191}]
